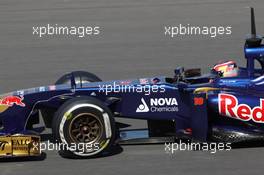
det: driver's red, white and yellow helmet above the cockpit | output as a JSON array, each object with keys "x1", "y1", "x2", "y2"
[{"x1": 213, "y1": 61, "x2": 238, "y2": 77}]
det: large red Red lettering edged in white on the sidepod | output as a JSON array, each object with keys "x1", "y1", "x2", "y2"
[{"x1": 218, "y1": 94, "x2": 264, "y2": 123}]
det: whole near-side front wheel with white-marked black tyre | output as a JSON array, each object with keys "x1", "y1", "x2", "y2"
[{"x1": 52, "y1": 97, "x2": 116, "y2": 158}]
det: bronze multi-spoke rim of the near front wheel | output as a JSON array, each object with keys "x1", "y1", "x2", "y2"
[{"x1": 69, "y1": 113, "x2": 103, "y2": 144}]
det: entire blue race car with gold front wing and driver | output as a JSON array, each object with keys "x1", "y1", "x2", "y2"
[{"x1": 0, "y1": 8, "x2": 264, "y2": 157}]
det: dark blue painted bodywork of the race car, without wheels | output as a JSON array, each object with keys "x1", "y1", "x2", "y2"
[{"x1": 0, "y1": 7, "x2": 264, "y2": 150}]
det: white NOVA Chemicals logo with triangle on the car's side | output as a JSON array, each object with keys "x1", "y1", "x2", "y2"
[{"x1": 136, "y1": 98, "x2": 178, "y2": 112}]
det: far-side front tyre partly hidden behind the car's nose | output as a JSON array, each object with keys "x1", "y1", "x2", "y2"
[{"x1": 55, "y1": 71, "x2": 102, "y2": 85}]
